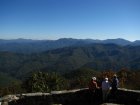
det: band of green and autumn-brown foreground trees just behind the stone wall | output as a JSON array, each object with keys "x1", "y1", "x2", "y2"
[{"x1": 0, "y1": 68, "x2": 140, "y2": 95}]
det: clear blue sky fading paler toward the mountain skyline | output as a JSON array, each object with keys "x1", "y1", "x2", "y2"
[{"x1": 0, "y1": 0, "x2": 140, "y2": 41}]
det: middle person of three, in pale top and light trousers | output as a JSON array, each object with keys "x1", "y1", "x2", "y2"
[{"x1": 102, "y1": 77, "x2": 111, "y2": 102}]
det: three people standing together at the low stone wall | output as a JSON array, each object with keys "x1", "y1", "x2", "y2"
[{"x1": 89, "y1": 74, "x2": 119, "y2": 102}]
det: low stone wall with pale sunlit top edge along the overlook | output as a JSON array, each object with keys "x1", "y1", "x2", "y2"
[{"x1": 1, "y1": 88, "x2": 140, "y2": 105}]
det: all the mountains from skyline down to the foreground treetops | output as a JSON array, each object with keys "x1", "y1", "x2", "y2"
[{"x1": 0, "y1": 38, "x2": 140, "y2": 81}]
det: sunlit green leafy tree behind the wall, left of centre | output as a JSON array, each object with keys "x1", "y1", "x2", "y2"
[{"x1": 23, "y1": 72, "x2": 68, "y2": 92}]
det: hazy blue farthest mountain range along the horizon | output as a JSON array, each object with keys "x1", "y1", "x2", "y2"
[{"x1": 0, "y1": 38, "x2": 140, "y2": 54}]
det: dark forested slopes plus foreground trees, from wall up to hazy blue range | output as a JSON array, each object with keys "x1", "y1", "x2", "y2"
[{"x1": 0, "y1": 43, "x2": 140, "y2": 94}]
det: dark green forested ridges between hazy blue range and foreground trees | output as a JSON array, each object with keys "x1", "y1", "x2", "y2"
[{"x1": 0, "y1": 42, "x2": 140, "y2": 78}]
